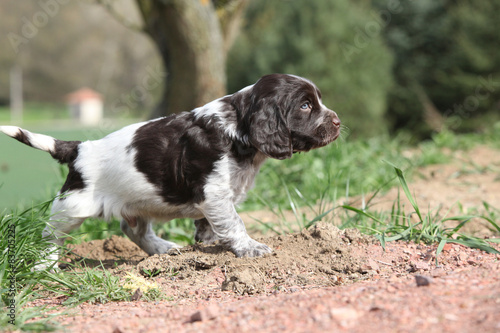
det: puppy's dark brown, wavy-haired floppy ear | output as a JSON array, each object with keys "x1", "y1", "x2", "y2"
[{"x1": 245, "y1": 98, "x2": 293, "y2": 160}]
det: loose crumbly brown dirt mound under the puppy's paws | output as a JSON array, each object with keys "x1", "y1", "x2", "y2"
[{"x1": 65, "y1": 223, "x2": 371, "y2": 296}]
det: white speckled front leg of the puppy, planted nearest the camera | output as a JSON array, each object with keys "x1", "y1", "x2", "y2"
[{"x1": 200, "y1": 202, "x2": 272, "y2": 257}]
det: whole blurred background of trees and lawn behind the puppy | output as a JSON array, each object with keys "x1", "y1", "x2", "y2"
[{"x1": 0, "y1": 0, "x2": 500, "y2": 209}]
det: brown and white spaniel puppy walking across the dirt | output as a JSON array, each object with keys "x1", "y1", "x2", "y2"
[{"x1": 0, "y1": 74, "x2": 340, "y2": 257}]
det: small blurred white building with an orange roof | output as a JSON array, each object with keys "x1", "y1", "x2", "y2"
[{"x1": 66, "y1": 88, "x2": 103, "y2": 126}]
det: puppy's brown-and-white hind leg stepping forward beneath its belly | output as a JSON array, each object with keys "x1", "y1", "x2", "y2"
[{"x1": 120, "y1": 217, "x2": 180, "y2": 255}]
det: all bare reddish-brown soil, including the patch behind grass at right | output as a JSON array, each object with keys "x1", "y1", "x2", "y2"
[{"x1": 18, "y1": 147, "x2": 500, "y2": 332}]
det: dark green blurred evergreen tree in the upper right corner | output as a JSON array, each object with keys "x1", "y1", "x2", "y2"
[{"x1": 373, "y1": 0, "x2": 500, "y2": 137}]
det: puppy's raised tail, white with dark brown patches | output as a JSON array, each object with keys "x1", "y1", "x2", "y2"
[{"x1": 0, "y1": 126, "x2": 81, "y2": 163}]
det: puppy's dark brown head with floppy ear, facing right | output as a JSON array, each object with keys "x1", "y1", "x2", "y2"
[{"x1": 237, "y1": 74, "x2": 340, "y2": 159}]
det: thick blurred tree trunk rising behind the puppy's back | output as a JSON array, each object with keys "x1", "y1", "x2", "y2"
[{"x1": 136, "y1": 0, "x2": 248, "y2": 117}]
